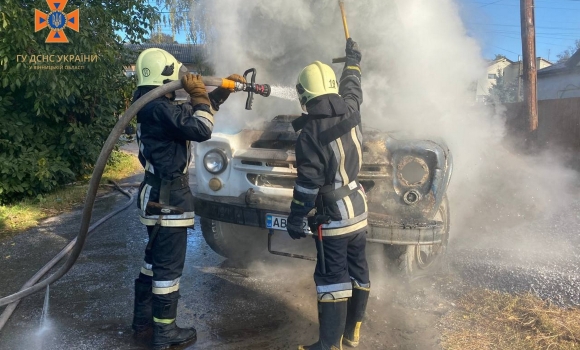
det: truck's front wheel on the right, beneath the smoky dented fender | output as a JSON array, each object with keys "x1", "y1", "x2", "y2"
[{"x1": 384, "y1": 196, "x2": 450, "y2": 278}]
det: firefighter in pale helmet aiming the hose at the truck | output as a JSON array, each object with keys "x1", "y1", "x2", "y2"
[{"x1": 133, "y1": 48, "x2": 245, "y2": 349}]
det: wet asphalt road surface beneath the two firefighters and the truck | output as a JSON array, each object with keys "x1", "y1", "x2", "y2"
[{"x1": 0, "y1": 145, "x2": 580, "y2": 350}]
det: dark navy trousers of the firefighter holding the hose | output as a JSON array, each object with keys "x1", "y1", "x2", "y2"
[{"x1": 138, "y1": 226, "x2": 187, "y2": 324}]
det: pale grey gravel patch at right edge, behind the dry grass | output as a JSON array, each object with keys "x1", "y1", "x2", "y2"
[{"x1": 449, "y1": 199, "x2": 580, "y2": 307}]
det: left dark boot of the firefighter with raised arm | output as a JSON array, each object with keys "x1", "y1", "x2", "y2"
[{"x1": 298, "y1": 298, "x2": 348, "y2": 350}]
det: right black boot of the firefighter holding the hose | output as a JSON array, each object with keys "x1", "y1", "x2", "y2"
[{"x1": 153, "y1": 298, "x2": 197, "y2": 350}]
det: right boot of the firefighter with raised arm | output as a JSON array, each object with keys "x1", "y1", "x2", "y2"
[{"x1": 342, "y1": 286, "x2": 370, "y2": 348}]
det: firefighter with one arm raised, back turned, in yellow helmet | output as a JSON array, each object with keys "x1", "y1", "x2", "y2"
[{"x1": 287, "y1": 39, "x2": 370, "y2": 350}]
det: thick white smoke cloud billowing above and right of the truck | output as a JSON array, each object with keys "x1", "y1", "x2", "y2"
[{"x1": 196, "y1": 0, "x2": 575, "y2": 246}]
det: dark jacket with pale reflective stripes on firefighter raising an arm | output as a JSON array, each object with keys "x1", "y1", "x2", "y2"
[{"x1": 290, "y1": 66, "x2": 368, "y2": 236}]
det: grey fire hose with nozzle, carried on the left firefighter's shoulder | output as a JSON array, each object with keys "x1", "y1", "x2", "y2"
[{"x1": 0, "y1": 72, "x2": 270, "y2": 330}]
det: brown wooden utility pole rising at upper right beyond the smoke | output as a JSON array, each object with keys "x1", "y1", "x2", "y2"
[{"x1": 520, "y1": 0, "x2": 538, "y2": 131}]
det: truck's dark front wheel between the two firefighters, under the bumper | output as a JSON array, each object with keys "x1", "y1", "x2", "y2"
[{"x1": 201, "y1": 218, "x2": 268, "y2": 261}]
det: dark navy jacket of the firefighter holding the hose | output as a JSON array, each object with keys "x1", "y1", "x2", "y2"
[{"x1": 133, "y1": 87, "x2": 215, "y2": 227}]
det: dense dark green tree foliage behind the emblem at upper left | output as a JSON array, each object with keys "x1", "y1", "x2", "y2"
[{"x1": 0, "y1": 0, "x2": 156, "y2": 204}]
